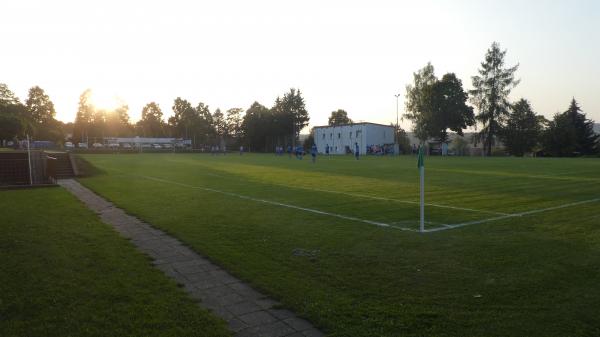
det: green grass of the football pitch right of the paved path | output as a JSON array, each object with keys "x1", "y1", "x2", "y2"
[{"x1": 77, "y1": 154, "x2": 600, "y2": 336}]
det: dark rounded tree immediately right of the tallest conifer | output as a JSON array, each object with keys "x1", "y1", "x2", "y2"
[{"x1": 500, "y1": 98, "x2": 542, "y2": 157}]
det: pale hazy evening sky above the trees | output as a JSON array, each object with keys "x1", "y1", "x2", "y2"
[{"x1": 0, "y1": 0, "x2": 600, "y2": 130}]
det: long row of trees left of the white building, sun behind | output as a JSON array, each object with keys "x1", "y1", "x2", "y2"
[{"x1": 0, "y1": 83, "x2": 310, "y2": 151}]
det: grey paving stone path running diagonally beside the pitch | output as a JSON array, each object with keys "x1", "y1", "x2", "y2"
[{"x1": 58, "y1": 179, "x2": 324, "y2": 337}]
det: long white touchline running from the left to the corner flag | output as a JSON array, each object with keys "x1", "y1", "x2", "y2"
[{"x1": 140, "y1": 175, "x2": 416, "y2": 232}]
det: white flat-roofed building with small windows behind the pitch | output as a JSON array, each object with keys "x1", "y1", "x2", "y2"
[{"x1": 314, "y1": 123, "x2": 395, "y2": 154}]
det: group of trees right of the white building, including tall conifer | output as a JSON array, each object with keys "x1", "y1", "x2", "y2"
[{"x1": 404, "y1": 42, "x2": 600, "y2": 156}]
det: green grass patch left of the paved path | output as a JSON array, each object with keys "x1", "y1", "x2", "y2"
[{"x1": 0, "y1": 188, "x2": 229, "y2": 337}]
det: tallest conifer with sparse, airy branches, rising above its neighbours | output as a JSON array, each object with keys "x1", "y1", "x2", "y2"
[{"x1": 470, "y1": 42, "x2": 520, "y2": 156}]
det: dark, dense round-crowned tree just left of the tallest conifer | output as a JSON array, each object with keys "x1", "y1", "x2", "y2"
[{"x1": 420, "y1": 73, "x2": 475, "y2": 143}]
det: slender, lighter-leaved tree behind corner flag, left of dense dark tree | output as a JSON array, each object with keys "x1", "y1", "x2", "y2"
[{"x1": 404, "y1": 62, "x2": 437, "y2": 142}]
